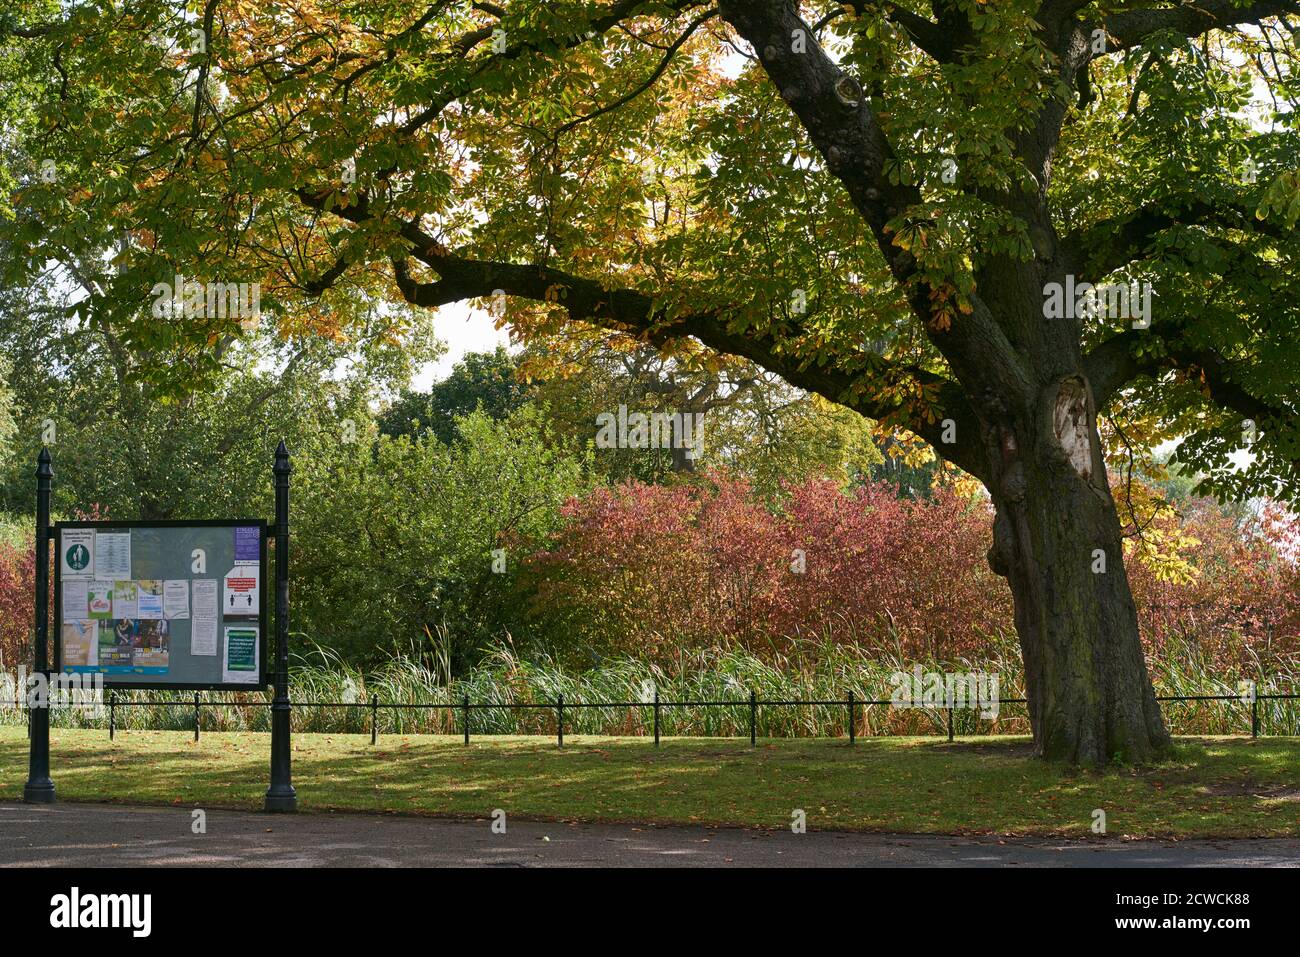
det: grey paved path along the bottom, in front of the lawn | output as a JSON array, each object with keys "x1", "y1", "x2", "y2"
[{"x1": 0, "y1": 802, "x2": 1300, "y2": 867}]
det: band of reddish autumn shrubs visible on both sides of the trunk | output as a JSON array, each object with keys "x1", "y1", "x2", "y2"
[{"x1": 525, "y1": 475, "x2": 1300, "y2": 675}]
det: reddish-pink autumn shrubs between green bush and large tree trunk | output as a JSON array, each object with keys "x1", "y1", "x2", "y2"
[{"x1": 528, "y1": 475, "x2": 1010, "y2": 659}]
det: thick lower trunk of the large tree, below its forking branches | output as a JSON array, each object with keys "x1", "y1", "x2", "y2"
[{"x1": 984, "y1": 376, "x2": 1170, "y2": 765}]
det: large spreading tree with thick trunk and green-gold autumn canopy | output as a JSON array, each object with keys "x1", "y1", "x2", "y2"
[{"x1": 0, "y1": 0, "x2": 1300, "y2": 763}]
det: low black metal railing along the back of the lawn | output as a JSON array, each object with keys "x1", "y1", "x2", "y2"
[{"x1": 5, "y1": 690, "x2": 1300, "y2": 748}]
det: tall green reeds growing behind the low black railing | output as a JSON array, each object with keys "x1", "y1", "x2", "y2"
[{"x1": 0, "y1": 636, "x2": 1300, "y2": 737}]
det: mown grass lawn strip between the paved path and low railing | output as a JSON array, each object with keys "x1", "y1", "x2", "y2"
[{"x1": 0, "y1": 727, "x2": 1300, "y2": 839}]
